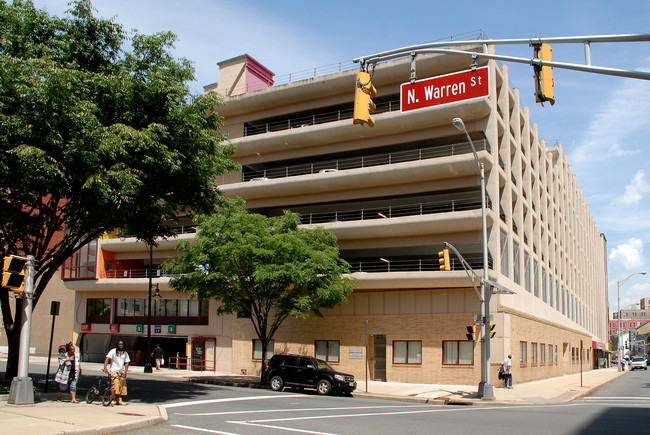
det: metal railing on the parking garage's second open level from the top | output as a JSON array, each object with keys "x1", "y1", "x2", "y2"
[{"x1": 242, "y1": 139, "x2": 490, "y2": 181}]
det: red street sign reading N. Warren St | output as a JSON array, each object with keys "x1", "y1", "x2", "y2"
[{"x1": 400, "y1": 66, "x2": 490, "y2": 112}]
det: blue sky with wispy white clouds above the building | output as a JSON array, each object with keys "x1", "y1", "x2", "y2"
[{"x1": 33, "y1": 0, "x2": 650, "y2": 312}]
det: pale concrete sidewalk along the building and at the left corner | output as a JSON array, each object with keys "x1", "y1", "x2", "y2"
[{"x1": 0, "y1": 356, "x2": 627, "y2": 435}]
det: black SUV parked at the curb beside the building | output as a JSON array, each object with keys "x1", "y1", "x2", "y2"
[{"x1": 264, "y1": 355, "x2": 357, "y2": 394}]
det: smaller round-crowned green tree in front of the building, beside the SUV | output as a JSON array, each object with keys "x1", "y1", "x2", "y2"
[{"x1": 166, "y1": 200, "x2": 354, "y2": 380}]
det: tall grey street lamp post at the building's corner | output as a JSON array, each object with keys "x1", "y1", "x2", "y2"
[{"x1": 451, "y1": 118, "x2": 494, "y2": 399}]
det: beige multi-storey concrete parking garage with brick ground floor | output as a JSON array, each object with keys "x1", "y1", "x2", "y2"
[{"x1": 54, "y1": 48, "x2": 608, "y2": 384}]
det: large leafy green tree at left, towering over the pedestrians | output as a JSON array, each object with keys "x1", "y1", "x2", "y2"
[{"x1": 0, "y1": 0, "x2": 237, "y2": 378}]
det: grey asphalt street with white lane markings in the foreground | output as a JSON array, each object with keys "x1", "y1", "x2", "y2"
[{"x1": 124, "y1": 371, "x2": 650, "y2": 435}]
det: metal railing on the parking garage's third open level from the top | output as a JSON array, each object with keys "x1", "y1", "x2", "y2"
[{"x1": 300, "y1": 198, "x2": 492, "y2": 225}]
